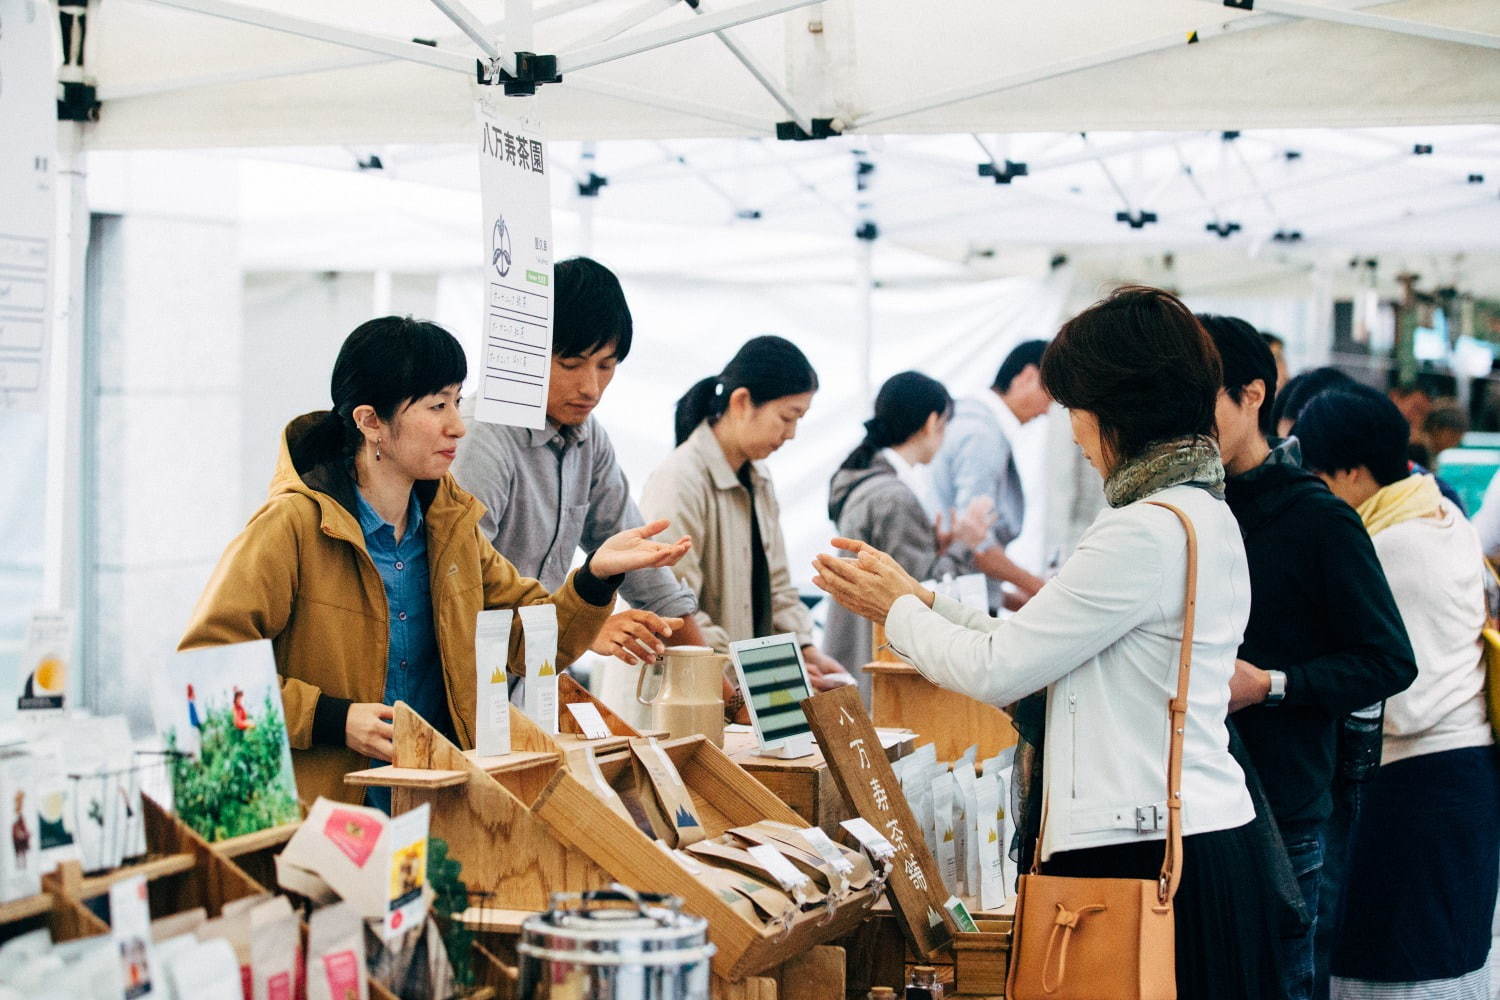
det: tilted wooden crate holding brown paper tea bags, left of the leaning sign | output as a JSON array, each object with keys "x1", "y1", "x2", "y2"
[{"x1": 533, "y1": 736, "x2": 869, "y2": 982}]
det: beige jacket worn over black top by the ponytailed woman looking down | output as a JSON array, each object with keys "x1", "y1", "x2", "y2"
[{"x1": 641, "y1": 421, "x2": 813, "y2": 652}]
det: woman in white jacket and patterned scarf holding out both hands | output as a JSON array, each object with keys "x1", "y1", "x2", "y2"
[{"x1": 815, "y1": 288, "x2": 1281, "y2": 1000}]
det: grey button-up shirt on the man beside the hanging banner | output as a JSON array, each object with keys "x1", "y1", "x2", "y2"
[{"x1": 453, "y1": 417, "x2": 698, "y2": 618}]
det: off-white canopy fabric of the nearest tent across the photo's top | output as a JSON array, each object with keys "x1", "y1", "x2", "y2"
[{"x1": 87, "y1": 0, "x2": 1500, "y2": 148}]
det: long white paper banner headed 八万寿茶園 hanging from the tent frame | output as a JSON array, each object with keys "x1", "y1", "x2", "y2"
[{"x1": 474, "y1": 97, "x2": 552, "y2": 429}]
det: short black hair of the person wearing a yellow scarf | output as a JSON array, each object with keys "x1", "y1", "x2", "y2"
[{"x1": 1293, "y1": 384, "x2": 1412, "y2": 486}]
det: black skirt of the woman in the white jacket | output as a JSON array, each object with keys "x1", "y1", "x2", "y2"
[{"x1": 1043, "y1": 823, "x2": 1283, "y2": 1000}]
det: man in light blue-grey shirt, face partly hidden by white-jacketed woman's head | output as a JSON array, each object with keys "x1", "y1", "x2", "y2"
[{"x1": 932, "y1": 340, "x2": 1052, "y2": 607}]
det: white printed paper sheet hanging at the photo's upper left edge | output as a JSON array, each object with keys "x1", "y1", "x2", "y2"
[{"x1": 0, "y1": 0, "x2": 57, "y2": 412}]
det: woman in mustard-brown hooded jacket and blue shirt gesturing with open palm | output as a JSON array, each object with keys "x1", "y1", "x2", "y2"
[{"x1": 180, "y1": 316, "x2": 692, "y2": 805}]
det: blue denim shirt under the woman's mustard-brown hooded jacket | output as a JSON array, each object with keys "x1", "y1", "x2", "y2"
[{"x1": 356, "y1": 489, "x2": 453, "y2": 811}]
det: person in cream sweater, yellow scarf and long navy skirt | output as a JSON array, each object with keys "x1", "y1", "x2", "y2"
[{"x1": 1293, "y1": 387, "x2": 1500, "y2": 1000}]
